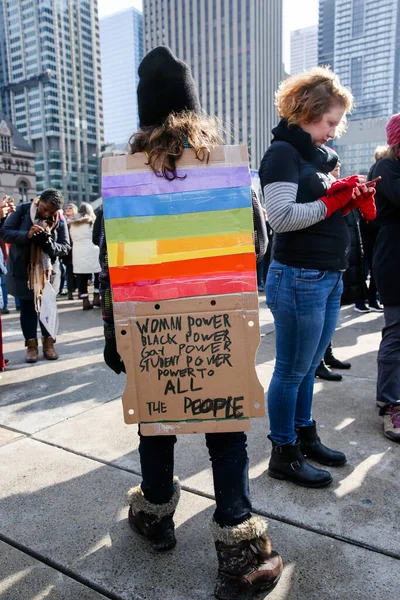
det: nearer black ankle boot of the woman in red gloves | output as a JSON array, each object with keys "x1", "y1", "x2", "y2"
[{"x1": 268, "y1": 436, "x2": 332, "y2": 488}]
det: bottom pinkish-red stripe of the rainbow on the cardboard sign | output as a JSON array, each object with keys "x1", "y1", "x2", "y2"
[{"x1": 112, "y1": 271, "x2": 257, "y2": 302}]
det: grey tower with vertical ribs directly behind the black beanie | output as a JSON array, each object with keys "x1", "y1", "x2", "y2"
[{"x1": 143, "y1": 0, "x2": 284, "y2": 168}]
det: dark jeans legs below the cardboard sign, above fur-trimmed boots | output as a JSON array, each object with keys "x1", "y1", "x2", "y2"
[{"x1": 139, "y1": 428, "x2": 251, "y2": 527}]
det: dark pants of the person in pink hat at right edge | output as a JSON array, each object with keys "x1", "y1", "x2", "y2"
[{"x1": 376, "y1": 305, "x2": 400, "y2": 414}]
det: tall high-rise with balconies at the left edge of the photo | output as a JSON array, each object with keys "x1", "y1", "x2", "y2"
[{"x1": 0, "y1": 0, "x2": 103, "y2": 202}]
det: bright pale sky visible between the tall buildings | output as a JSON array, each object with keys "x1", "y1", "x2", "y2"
[{"x1": 98, "y1": 0, "x2": 318, "y2": 70}]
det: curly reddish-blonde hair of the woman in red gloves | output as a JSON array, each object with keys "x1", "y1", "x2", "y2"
[{"x1": 275, "y1": 67, "x2": 354, "y2": 136}]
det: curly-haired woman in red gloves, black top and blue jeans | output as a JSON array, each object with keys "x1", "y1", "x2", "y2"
[{"x1": 260, "y1": 67, "x2": 375, "y2": 488}]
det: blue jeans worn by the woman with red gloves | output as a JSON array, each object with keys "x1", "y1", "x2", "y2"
[{"x1": 265, "y1": 260, "x2": 343, "y2": 446}]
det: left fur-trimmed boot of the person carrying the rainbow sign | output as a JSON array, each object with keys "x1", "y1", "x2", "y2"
[{"x1": 128, "y1": 477, "x2": 181, "y2": 552}]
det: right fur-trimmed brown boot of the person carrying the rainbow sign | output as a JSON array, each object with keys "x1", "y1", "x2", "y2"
[{"x1": 211, "y1": 517, "x2": 282, "y2": 600}]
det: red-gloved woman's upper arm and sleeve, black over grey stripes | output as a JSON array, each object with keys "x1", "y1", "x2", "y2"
[{"x1": 260, "y1": 142, "x2": 326, "y2": 233}]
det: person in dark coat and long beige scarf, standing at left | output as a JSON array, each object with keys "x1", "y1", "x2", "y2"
[{"x1": 0, "y1": 189, "x2": 70, "y2": 362}]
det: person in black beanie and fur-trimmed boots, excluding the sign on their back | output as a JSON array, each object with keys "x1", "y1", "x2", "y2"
[{"x1": 100, "y1": 47, "x2": 282, "y2": 600}]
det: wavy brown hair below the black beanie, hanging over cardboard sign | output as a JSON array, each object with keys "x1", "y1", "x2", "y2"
[{"x1": 129, "y1": 111, "x2": 222, "y2": 181}]
